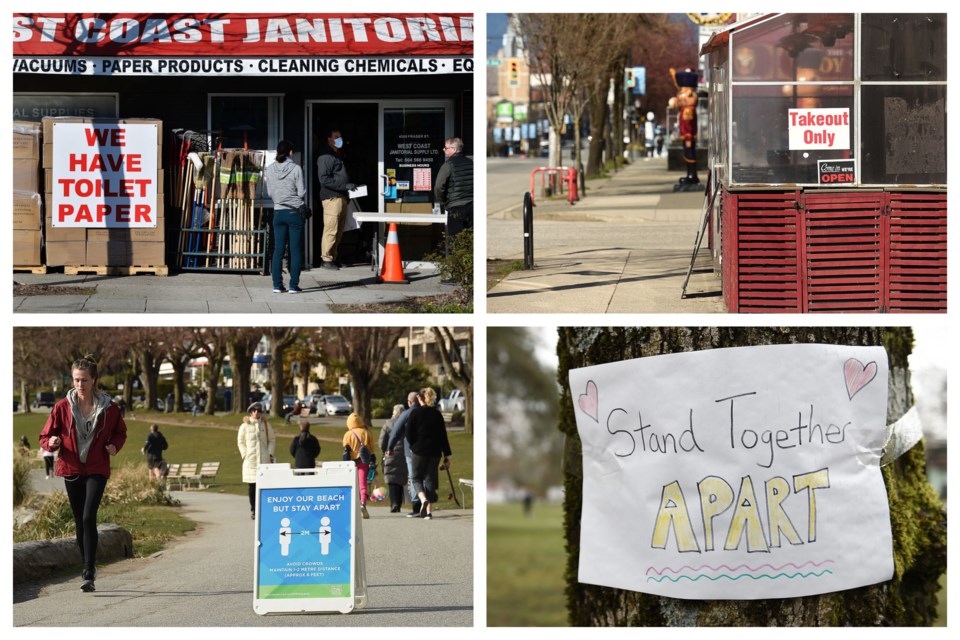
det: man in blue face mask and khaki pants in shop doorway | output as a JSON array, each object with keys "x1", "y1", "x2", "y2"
[{"x1": 317, "y1": 129, "x2": 356, "y2": 271}]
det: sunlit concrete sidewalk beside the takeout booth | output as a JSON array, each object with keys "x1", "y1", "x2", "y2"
[{"x1": 487, "y1": 158, "x2": 726, "y2": 313}]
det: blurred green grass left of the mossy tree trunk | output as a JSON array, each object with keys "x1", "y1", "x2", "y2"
[{"x1": 487, "y1": 504, "x2": 567, "y2": 627}]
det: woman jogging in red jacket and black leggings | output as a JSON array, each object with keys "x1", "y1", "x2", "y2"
[{"x1": 40, "y1": 356, "x2": 127, "y2": 592}]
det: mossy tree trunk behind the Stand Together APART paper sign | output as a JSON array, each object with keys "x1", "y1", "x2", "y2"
[{"x1": 557, "y1": 327, "x2": 947, "y2": 626}]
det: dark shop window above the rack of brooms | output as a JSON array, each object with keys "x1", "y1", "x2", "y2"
[{"x1": 209, "y1": 94, "x2": 281, "y2": 149}]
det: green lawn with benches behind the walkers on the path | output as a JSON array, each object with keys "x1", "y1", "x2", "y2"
[{"x1": 13, "y1": 413, "x2": 474, "y2": 508}]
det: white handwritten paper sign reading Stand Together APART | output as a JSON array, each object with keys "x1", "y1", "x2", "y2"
[{"x1": 570, "y1": 345, "x2": 893, "y2": 599}]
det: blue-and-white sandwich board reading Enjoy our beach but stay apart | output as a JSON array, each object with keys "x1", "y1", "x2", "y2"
[{"x1": 253, "y1": 462, "x2": 366, "y2": 615}]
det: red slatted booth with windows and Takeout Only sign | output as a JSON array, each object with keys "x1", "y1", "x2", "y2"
[{"x1": 701, "y1": 13, "x2": 947, "y2": 313}]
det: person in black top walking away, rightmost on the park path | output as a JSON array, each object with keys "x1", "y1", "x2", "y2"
[{"x1": 407, "y1": 387, "x2": 453, "y2": 520}]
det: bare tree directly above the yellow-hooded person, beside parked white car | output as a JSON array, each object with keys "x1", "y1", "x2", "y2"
[{"x1": 334, "y1": 327, "x2": 404, "y2": 422}]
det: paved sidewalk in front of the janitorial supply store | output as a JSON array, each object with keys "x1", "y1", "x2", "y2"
[{"x1": 13, "y1": 263, "x2": 454, "y2": 313}]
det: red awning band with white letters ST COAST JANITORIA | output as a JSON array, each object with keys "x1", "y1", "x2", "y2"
[{"x1": 13, "y1": 13, "x2": 473, "y2": 57}]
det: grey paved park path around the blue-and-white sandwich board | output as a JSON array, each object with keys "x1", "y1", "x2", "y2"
[{"x1": 13, "y1": 484, "x2": 473, "y2": 627}]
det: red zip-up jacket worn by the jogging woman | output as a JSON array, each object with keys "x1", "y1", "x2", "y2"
[{"x1": 40, "y1": 398, "x2": 127, "y2": 478}]
